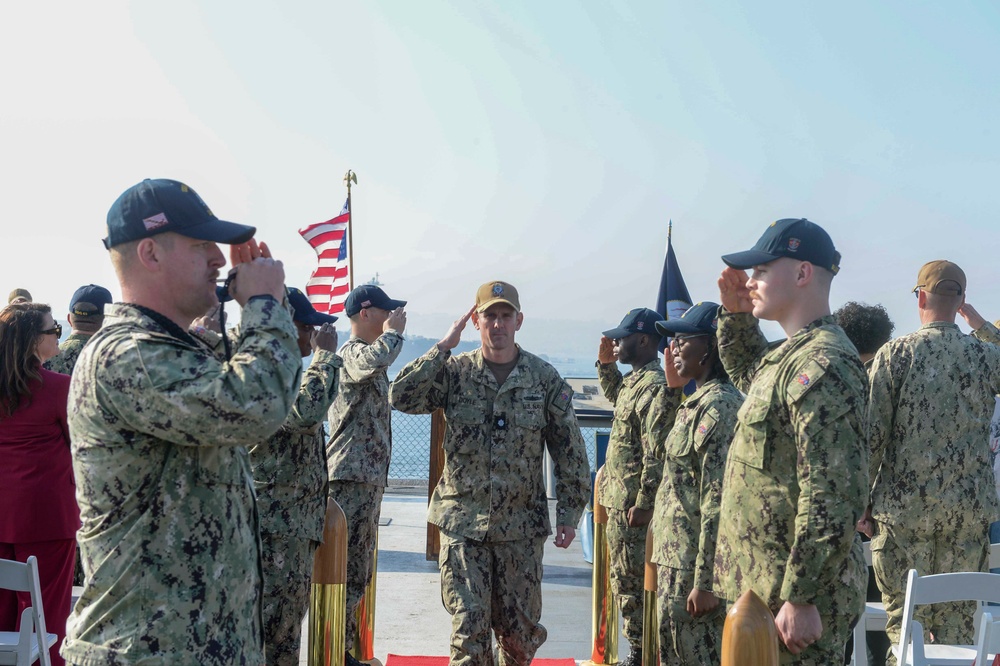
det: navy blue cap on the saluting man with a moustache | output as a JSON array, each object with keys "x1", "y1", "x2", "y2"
[{"x1": 722, "y1": 217, "x2": 840, "y2": 275}]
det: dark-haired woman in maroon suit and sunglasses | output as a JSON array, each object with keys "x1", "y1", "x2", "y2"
[{"x1": 0, "y1": 303, "x2": 80, "y2": 666}]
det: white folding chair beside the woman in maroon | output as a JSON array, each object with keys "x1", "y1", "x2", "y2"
[{"x1": 0, "y1": 555, "x2": 58, "y2": 666}]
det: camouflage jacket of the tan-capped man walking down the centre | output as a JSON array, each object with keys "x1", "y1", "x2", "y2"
[{"x1": 389, "y1": 345, "x2": 590, "y2": 542}]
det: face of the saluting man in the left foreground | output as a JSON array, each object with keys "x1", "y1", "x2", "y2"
[{"x1": 160, "y1": 234, "x2": 226, "y2": 320}]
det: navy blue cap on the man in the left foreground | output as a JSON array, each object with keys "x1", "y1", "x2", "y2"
[{"x1": 104, "y1": 178, "x2": 257, "y2": 250}]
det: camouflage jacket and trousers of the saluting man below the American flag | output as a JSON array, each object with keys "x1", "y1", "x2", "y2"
[{"x1": 326, "y1": 330, "x2": 403, "y2": 645}]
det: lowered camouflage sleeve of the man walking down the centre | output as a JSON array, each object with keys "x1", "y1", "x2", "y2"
[{"x1": 544, "y1": 378, "x2": 590, "y2": 528}]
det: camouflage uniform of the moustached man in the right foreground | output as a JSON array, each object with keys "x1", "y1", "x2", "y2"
[{"x1": 715, "y1": 310, "x2": 868, "y2": 666}]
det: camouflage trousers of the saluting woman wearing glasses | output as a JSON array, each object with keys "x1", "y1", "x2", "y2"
[{"x1": 656, "y1": 564, "x2": 726, "y2": 666}]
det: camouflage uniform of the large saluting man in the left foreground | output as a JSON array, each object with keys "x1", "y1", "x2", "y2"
[{"x1": 62, "y1": 296, "x2": 302, "y2": 666}]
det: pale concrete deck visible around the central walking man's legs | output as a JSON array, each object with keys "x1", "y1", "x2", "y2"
[{"x1": 300, "y1": 490, "x2": 628, "y2": 664}]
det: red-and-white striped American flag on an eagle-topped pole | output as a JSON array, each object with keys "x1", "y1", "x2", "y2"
[{"x1": 299, "y1": 201, "x2": 351, "y2": 314}]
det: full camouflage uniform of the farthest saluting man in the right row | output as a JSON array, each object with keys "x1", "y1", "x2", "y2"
[{"x1": 597, "y1": 359, "x2": 676, "y2": 651}]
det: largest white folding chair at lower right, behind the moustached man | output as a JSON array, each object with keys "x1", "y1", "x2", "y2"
[{"x1": 892, "y1": 569, "x2": 1000, "y2": 666}]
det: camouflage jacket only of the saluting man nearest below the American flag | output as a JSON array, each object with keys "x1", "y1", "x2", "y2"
[{"x1": 326, "y1": 330, "x2": 403, "y2": 482}]
